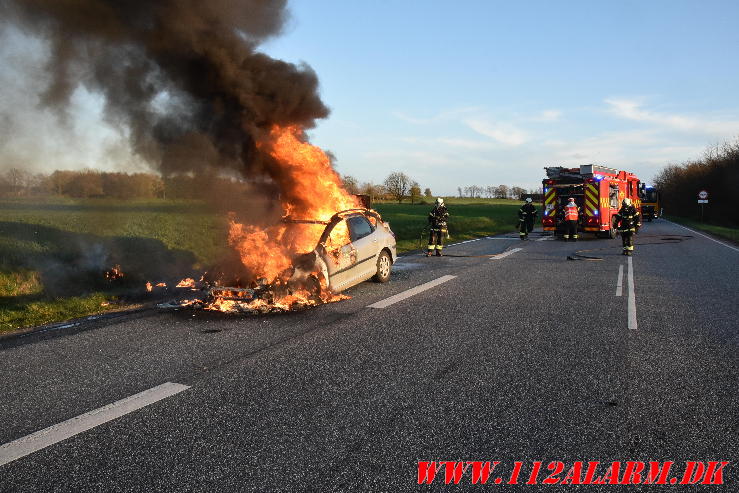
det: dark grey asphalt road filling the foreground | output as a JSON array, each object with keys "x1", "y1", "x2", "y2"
[{"x1": 0, "y1": 221, "x2": 739, "y2": 492}]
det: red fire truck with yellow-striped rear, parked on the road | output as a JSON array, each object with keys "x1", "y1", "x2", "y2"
[{"x1": 542, "y1": 164, "x2": 644, "y2": 238}]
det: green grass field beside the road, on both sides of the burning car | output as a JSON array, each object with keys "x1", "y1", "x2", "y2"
[{"x1": 0, "y1": 198, "x2": 520, "y2": 333}]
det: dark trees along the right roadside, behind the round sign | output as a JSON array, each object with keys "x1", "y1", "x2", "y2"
[{"x1": 654, "y1": 139, "x2": 739, "y2": 226}]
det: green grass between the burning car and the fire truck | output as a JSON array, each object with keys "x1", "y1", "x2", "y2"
[{"x1": 375, "y1": 199, "x2": 521, "y2": 252}]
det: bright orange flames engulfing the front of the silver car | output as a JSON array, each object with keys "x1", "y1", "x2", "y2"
[{"x1": 177, "y1": 126, "x2": 361, "y2": 313}]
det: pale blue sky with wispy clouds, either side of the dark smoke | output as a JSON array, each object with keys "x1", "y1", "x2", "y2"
[{"x1": 0, "y1": 0, "x2": 739, "y2": 195}]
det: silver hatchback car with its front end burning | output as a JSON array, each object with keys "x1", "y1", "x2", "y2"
[{"x1": 293, "y1": 208, "x2": 398, "y2": 293}]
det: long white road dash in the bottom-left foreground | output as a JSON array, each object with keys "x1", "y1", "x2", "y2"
[{"x1": 0, "y1": 382, "x2": 190, "y2": 466}]
